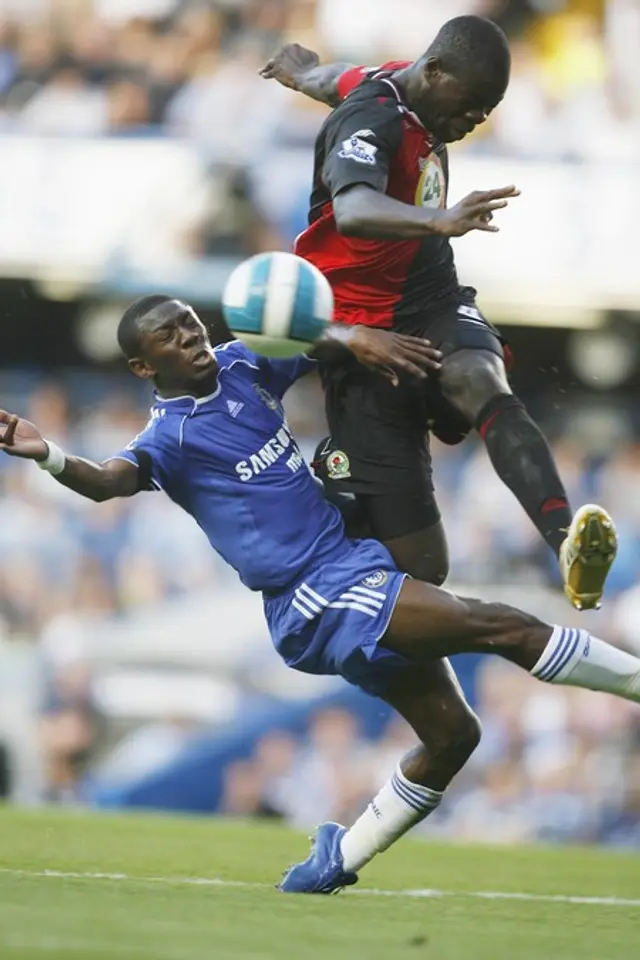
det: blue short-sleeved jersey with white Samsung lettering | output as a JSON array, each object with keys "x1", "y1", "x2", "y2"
[{"x1": 112, "y1": 340, "x2": 349, "y2": 594}]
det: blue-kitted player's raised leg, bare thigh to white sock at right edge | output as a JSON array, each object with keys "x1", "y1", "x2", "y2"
[{"x1": 380, "y1": 580, "x2": 640, "y2": 703}]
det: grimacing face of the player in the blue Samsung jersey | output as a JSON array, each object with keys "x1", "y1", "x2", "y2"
[{"x1": 130, "y1": 300, "x2": 216, "y2": 392}]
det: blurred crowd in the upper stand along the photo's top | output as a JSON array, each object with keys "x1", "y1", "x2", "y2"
[{"x1": 0, "y1": 0, "x2": 640, "y2": 162}]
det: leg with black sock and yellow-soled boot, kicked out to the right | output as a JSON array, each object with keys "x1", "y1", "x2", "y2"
[{"x1": 441, "y1": 314, "x2": 617, "y2": 609}]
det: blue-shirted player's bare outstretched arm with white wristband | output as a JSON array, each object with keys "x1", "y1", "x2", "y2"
[{"x1": 0, "y1": 410, "x2": 138, "y2": 503}]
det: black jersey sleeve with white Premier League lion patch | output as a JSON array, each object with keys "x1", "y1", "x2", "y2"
[{"x1": 322, "y1": 97, "x2": 402, "y2": 199}]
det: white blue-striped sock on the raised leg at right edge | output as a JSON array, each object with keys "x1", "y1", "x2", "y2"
[{"x1": 531, "y1": 627, "x2": 640, "y2": 703}]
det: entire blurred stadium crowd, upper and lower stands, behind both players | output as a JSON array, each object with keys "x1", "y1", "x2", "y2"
[{"x1": 0, "y1": 0, "x2": 640, "y2": 846}]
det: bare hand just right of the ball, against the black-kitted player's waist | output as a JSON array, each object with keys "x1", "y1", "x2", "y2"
[{"x1": 349, "y1": 326, "x2": 442, "y2": 386}]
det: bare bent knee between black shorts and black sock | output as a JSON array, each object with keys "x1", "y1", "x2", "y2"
[{"x1": 440, "y1": 350, "x2": 511, "y2": 423}]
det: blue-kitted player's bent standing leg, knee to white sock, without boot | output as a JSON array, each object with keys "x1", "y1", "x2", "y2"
[{"x1": 340, "y1": 660, "x2": 480, "y2": 873}]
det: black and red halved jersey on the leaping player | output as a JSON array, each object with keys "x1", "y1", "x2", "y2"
[{"x1": 295, "y1": 62, "x2": 473, "y2": 327}]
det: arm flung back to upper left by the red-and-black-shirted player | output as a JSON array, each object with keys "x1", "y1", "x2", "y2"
[{"x1": 260, "y1": 43, "x2": 353, "y2": 107}]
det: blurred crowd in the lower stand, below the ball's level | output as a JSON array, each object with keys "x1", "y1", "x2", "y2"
[{"x1": 0, "y1": 374, "x2": 640, "y2": 845}]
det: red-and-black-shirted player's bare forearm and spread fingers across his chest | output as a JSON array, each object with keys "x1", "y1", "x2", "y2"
[{"x1": 333, "y1": 183, "x2": 520, "y2": 240}]
